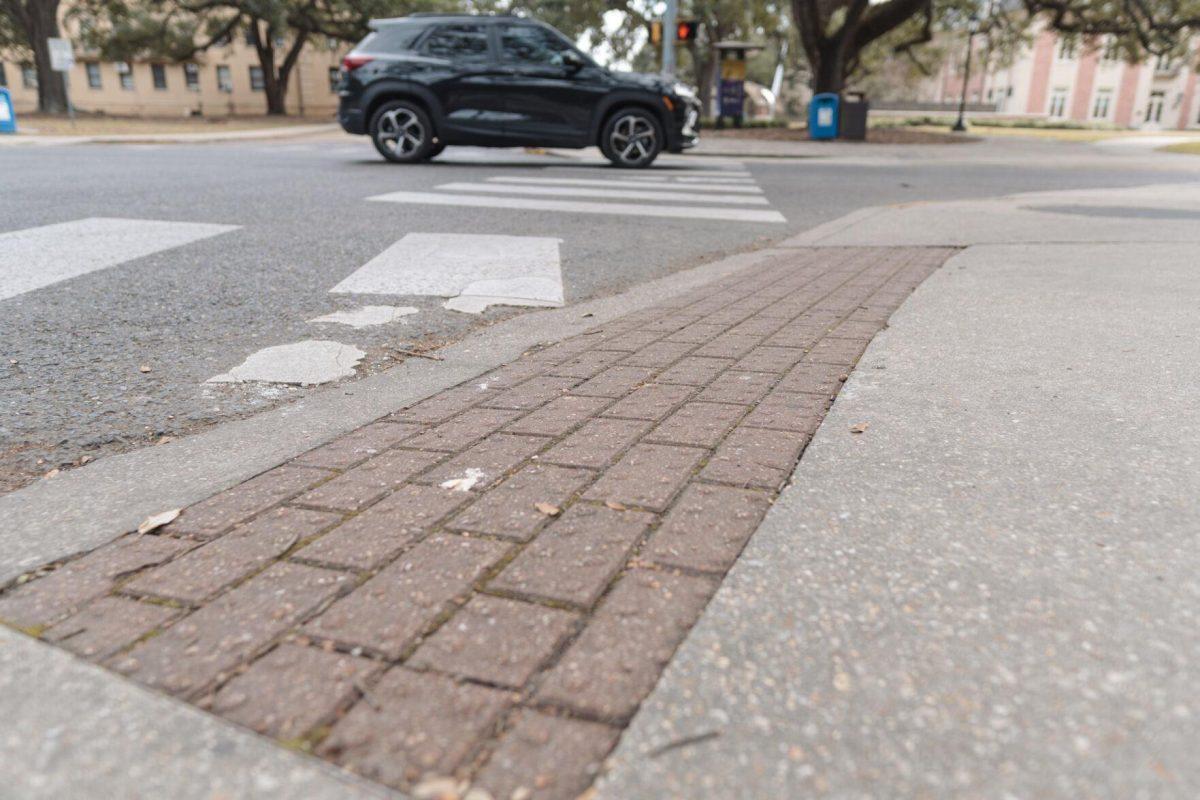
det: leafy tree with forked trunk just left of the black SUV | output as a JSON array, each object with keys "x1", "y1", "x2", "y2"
[{"x1": 73, "y1": 0, "x2": 448, "y2": 114}]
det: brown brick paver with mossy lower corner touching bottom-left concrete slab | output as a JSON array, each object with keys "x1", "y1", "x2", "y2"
[{"x1": 208, "y1": 643, "x2": 384, "y2": 740}]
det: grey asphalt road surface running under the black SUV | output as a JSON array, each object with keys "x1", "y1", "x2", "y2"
[{"x1": 0, "y1": 136, "x2": 1193, "y2": 491}]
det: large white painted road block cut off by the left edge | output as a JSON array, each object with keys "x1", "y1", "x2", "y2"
[{"x1": 0, "y1": 217, "x2": 238, "y2": 300}]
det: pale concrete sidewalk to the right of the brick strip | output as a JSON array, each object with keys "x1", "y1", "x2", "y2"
[{"x1": 600, "y1": 185, "x2": 1200, "y2": 800}]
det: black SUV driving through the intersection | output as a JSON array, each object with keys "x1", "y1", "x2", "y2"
[{"x1": 337, "y1": 14, "x2": 700, "y2": 167}]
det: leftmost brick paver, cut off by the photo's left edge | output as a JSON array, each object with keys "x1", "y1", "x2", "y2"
[{"x1": 0, "y1": 536, "x2": 191, "y2": 628}]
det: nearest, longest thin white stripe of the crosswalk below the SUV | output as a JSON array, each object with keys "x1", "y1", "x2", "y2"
[{"x1": 367, "y1": 192, "x2": 787, "y2": 222}]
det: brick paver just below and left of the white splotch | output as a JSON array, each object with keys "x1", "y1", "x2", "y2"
[{"x1": 294, "y1": 486, "x2": 470, "y2": 570}]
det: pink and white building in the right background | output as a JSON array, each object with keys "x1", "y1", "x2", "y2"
[{"x1": 923, "y1": 30, "x2": 1200, "y2": 131}]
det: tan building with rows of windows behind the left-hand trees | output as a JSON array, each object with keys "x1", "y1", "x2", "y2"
[{"x1": 0, "y1": 34, "x2": 350, "y2": 118}]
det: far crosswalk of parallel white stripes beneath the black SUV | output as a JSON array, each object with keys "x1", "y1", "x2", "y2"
[{"x1": 367, "y1": 169, "x2": 787, "y2": 224}]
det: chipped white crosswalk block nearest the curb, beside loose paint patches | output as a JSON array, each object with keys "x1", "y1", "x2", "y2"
[{"x1": 330, "y1": 231, "x2": 563, "y2": 313}]
